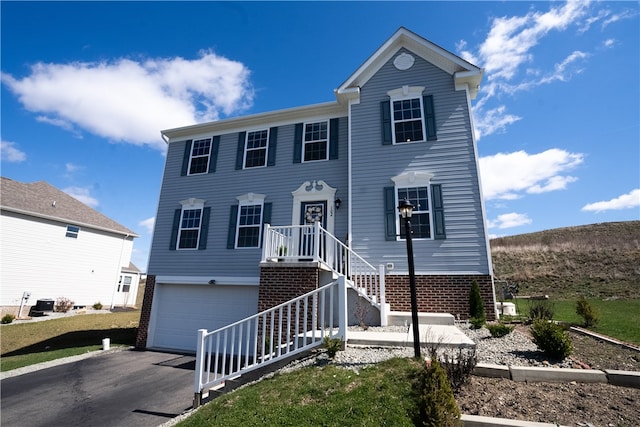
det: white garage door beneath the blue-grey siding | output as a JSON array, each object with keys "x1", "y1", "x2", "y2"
[{"x1": 147, "y1": 284, "x2": 258, "y2": 351}]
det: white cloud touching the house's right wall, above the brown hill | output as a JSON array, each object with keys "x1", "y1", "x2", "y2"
[{"x1": 480, "y1": 148, "x2": 584, "y2": 200}]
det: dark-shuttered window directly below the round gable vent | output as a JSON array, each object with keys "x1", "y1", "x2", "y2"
[{"x1": 382, "y1": 86, "x2": 437, "y2": 144}]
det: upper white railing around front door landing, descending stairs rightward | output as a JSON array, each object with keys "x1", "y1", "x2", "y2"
[{"x1": 262, "y1": 222, "x2": 386, "y2": 314}]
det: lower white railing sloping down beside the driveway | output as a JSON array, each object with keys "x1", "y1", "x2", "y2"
[{"x1": 193, "y1": 277, "x2": 347, "y2": 408}]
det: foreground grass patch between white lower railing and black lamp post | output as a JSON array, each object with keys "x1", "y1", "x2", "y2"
[{"x1": 178, "y1": 359, "x2": 418, "y2": 427}]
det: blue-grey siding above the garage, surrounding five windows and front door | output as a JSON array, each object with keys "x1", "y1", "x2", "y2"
[{"x1": 148, "y1": 117, "x2": 348, "y2": 277}]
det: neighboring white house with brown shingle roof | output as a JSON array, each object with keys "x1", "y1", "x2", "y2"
[{"x1": 0, "y1": 177, "x2": 140, "y2": 315}]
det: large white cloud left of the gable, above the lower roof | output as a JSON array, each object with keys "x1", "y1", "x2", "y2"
[{"x1": 2, "y1": 51, "x2": 254, "y2": 150}]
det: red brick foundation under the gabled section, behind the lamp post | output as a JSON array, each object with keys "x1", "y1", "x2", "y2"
[{"x1": 385, "y1": 275, "x2": 495, "y2": 320}]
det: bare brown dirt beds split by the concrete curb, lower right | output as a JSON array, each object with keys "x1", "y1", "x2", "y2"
[{"x1": 456, "y1": 332, "x2": 640, "y2": 427}]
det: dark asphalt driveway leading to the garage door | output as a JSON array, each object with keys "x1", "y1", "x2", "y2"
[{"x1": 0, "y1": 350, "x2": 195, "y2": 427}]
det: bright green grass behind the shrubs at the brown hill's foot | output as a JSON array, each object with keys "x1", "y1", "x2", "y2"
[{"x1": 516, "y1": 299, "x2": 640, "y2": 344}]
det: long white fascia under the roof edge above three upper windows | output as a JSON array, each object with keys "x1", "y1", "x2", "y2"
[{"x1": 161, "y1": 101, "x2": 348, "y2": 143}]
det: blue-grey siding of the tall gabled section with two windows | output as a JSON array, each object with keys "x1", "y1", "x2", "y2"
[{"x1": 352, "y1": 49, "x2": 491, "y2": 274}]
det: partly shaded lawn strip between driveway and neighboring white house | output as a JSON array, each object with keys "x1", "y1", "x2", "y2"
[{"x1": 0, "y1": 310, "x2": 140, "y2": 372}]
